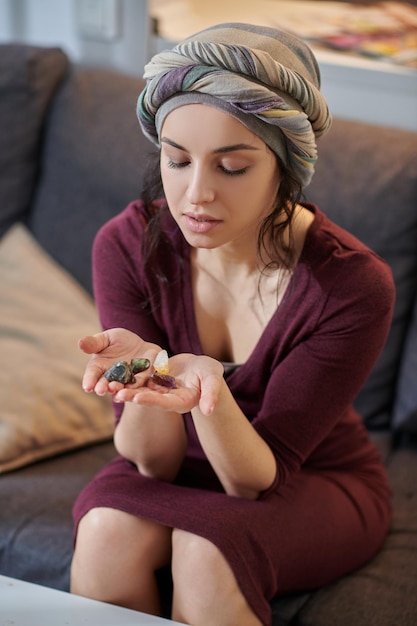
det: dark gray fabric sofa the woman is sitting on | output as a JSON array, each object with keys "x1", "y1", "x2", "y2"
[{"x1": 0, "y1": 44, "x2": 417, "y2": 626}]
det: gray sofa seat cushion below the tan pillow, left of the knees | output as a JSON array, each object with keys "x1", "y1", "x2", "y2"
[{"x1": 0, "y1": 442, "x2": 116, "y2": 588}]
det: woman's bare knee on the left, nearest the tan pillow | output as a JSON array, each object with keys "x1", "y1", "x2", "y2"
[{"x1": 71, "y1": 508, "x2": 172, "y2": 615}]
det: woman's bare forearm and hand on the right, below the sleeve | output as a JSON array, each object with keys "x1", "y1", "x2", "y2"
[{"x1": 116, "y1": 354, "x2": 276, "y2": 499}]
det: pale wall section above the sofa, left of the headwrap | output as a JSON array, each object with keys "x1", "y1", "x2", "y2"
[{"x1": 0, "y1": 0, "x2": 150, "y2": 75}]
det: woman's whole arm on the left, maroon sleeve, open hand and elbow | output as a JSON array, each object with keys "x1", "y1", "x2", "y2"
[{"x1": 88, "y1": 202, "x2": 192, "y2": 480}]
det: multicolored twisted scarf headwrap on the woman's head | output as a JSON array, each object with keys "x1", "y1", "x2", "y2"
[{"x1": 137, "y1": 23, "x2": 331, "y2": 187}]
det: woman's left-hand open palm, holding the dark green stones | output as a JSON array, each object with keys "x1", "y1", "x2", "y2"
[{"x1": 78, "y1": 328, "x2": 161, "y2": 395}]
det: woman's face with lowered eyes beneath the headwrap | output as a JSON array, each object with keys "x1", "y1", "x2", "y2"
[{"x1": 160, "y1": 104, "x2": 279, "y2": 249}]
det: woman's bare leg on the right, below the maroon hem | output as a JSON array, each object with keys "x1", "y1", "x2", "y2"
[{"x1": 172, "y1": 529, "x2": 262, "y2": 626}]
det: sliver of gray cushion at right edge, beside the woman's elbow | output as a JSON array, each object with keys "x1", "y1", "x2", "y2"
[{"x1": 393, "y1": 299, "x2": 417, "y2": 433}]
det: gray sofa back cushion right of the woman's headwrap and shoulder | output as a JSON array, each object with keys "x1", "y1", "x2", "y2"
[{"x1": 306, "y1": 120, "x2": 417, "y2": 429}]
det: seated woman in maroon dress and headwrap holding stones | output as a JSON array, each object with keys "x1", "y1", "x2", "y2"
[{"x1": 72, "y1": 24, "x2": 394, "y2": 626}]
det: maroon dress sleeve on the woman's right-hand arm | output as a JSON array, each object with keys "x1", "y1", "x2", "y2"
[{"x1": 253, "y1": 254, "x2": 394, "y2": 486}]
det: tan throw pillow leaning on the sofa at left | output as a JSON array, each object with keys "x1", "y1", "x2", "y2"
[{"x1": 0, "y1": 224, "x2": 113, "y2": 472}]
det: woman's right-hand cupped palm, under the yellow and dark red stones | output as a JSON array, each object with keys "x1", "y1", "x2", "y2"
[{"x1": 114, "y1": 354, "x2": 223, "y2": 415}]
